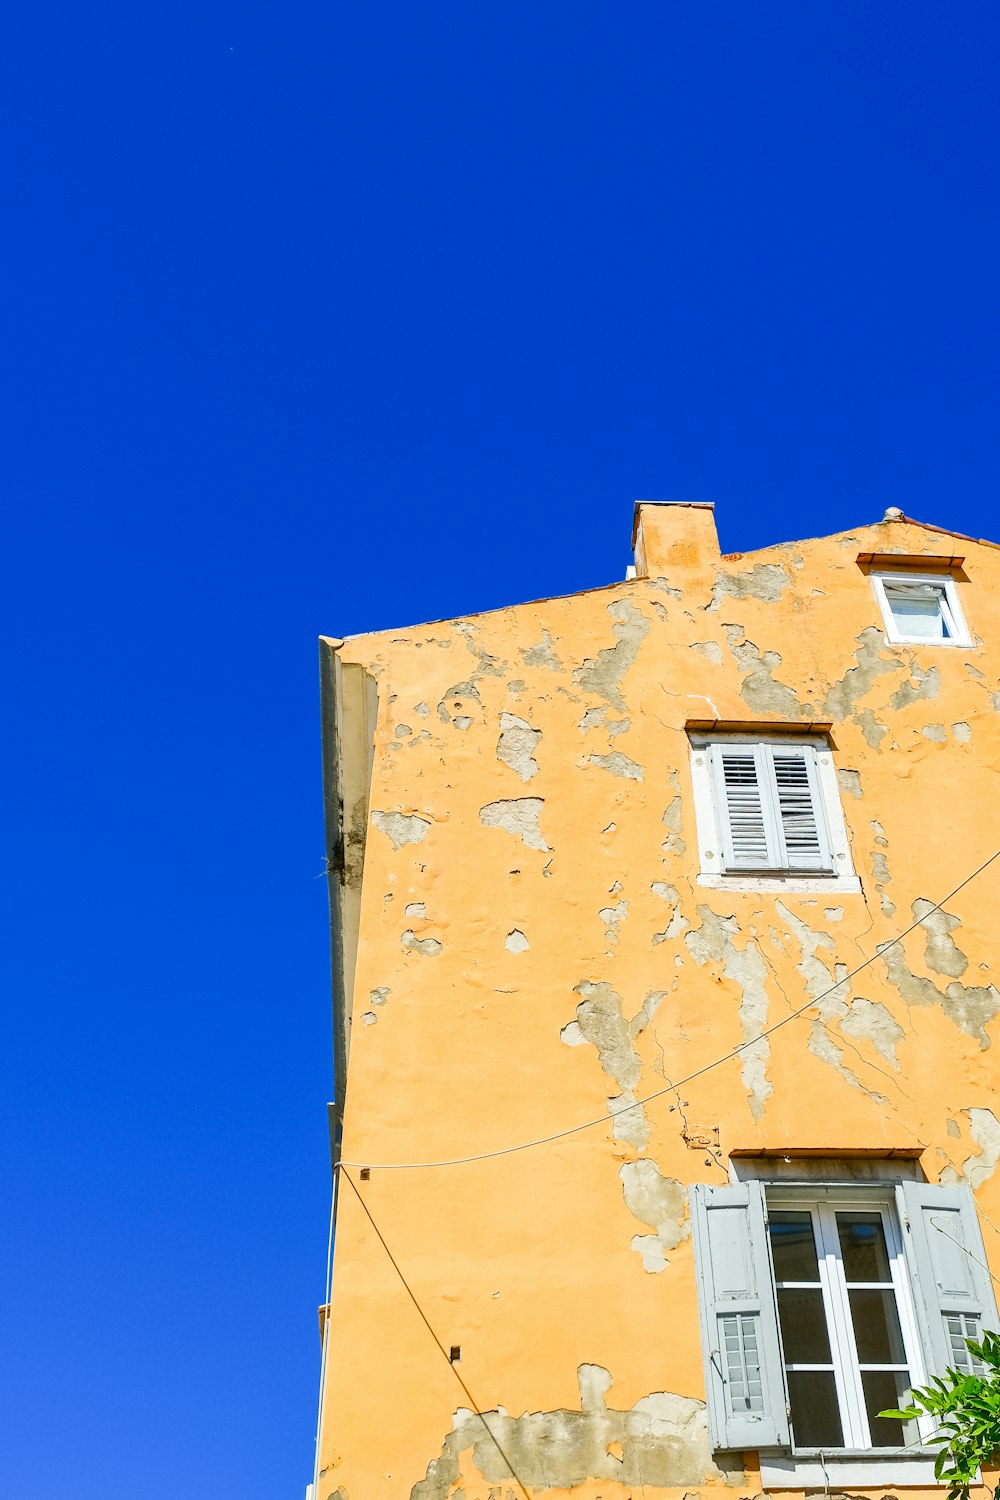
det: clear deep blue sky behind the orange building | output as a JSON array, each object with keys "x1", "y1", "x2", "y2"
[{"x1": 0, "y1": 0, "x2": 1000, "y2": 1500}]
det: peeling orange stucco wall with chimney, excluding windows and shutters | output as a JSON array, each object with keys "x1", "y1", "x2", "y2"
[{"x1": 316, "y1": 507, "x2": 1000, "y2": 1500}]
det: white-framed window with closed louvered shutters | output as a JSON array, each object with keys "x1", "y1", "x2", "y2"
[{"x1": 691, "y1": 735, "x2": 858, "y2": 890}]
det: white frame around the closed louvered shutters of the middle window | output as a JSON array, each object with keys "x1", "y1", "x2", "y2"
[{"x1": 690, "y1": 732, "x2": 861, "y2": 894}]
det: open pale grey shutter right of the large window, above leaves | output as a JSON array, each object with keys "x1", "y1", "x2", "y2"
[{"x1": 897, "y1": 1182, "x2": 1000, "y2": 1376}]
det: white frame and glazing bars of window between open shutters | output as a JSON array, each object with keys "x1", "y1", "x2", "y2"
[{"x1": 766, "y1": 1188, "x2": 934, "y2": 1460}]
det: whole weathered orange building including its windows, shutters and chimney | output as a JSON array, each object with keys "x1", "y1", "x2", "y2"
[{"x1": 315, "y1": 504, "x2": 1000, "y2": 1500}]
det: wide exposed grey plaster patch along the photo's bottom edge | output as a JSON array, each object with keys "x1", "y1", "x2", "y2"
[{"x1": 409, "y1": 1365, "x2": 745, "y2": 1500}]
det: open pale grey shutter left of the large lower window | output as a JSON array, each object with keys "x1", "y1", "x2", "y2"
[{"x1": 691, "y1": 1182, "x2": 789, "y2": 1449}]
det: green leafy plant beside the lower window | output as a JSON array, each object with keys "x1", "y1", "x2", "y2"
[{"x1": 879, "y1": 1334, "x2": 1000, "y2": 1500}]
